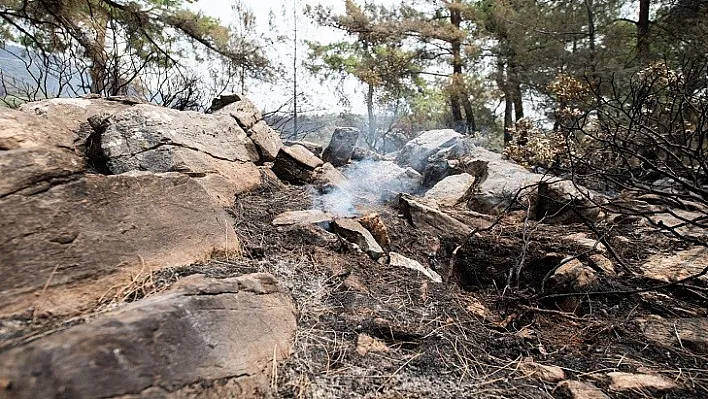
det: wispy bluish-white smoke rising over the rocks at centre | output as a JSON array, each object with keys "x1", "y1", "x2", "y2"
[{"x1": 312, "y1": 159, "x2": 422, "y2": 217}]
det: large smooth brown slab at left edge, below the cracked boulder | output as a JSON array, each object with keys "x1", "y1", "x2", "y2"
[{"x1": 0, "y1": 172, "x2": 240, "y2": 315}]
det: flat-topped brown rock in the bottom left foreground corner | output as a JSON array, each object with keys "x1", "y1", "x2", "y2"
[{"x1": 0, "y1": 274, "x2": 297, "y2": 399}]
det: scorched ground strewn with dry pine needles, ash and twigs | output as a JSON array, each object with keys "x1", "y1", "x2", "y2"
[{"x1": 0, "y1": 184, "x2": 708, "y2": 398}]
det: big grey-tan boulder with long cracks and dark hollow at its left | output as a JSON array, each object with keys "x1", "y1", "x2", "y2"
[{"x1": 88, "y1": 105, "x2": 266, "y2": 206}]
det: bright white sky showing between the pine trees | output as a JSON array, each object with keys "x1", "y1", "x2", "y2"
[{"x1": 191, "y1": 0, "x2": 397, "y2": 114}]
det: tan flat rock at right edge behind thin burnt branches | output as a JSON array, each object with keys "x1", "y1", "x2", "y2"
[{"x1": 640, "y1": 247, "x2": 708, "y2": 283}]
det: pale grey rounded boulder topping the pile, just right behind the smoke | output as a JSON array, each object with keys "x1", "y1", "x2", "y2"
[{"x1": 396, "y1": 129, "x2": 464, "y2": 174}]
